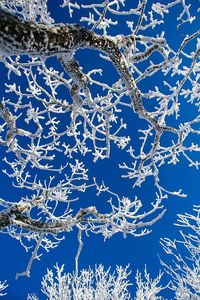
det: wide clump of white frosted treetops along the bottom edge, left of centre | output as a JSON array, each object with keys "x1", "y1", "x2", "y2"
[{"x1": 27, "y1": 265, "x2": 131, "y2": 300}]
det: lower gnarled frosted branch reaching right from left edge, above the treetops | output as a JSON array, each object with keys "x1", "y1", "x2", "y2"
[{"x1": 0, "y1": 203, "x2": 165, "y2": 236}]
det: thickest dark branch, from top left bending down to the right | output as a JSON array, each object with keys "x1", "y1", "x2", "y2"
[{"x1": 0, "y1": 9, "x2": 161, "y2": 131}]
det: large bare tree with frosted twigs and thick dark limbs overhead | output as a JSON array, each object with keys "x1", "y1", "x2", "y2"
[{"x1": 0, "y1": 0, "x2": 200, "y2": 275}]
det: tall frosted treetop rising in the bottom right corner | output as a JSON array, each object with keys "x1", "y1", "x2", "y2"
[{"x1": 161, "y1": 206, "x2": 200, "y2": 300}]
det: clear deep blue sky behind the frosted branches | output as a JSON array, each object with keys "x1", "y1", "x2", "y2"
[{"x1": 0, "y1": 1, "x2": 200, "y2": 300}]
